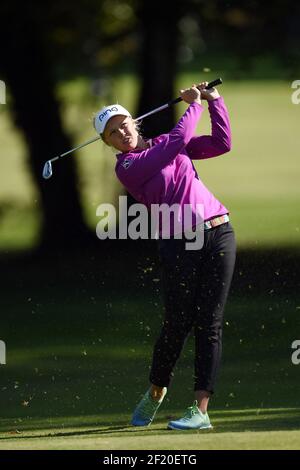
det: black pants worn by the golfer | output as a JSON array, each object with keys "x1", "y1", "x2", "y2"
[{"x1": 150, "y1": 222, "x2": 236, "y2": 393}]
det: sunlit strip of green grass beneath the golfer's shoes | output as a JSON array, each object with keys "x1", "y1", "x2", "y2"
[{"x1": 0, "y1": 409, "x2": 300, "y2": 450}]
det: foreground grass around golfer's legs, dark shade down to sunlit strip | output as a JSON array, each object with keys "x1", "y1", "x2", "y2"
[{"x1": 0, "y1": 261, "x2": 300, "y2": 450}]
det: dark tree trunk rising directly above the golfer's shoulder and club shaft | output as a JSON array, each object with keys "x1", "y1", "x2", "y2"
[{"x1": 137, "y1": 0, "x2": 182, "y2": 137}]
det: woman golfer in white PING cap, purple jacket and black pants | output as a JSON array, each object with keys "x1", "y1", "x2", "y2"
[{"x1": 94, "y1": 82, "x2": 236, "y2": 430}]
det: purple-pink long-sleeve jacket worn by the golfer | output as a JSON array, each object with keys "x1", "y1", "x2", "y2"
[{"x1": 115, "y1": 97, "x2": 231, "y2": 235}]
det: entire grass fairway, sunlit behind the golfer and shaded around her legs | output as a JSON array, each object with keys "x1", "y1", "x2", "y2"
[{"x1": 0, "y1": 71, "x2": 300, "y2": 450}]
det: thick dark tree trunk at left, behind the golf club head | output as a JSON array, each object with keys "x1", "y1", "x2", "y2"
[{"x1": 1, "y1": 4, "x2": 92, "y2": 251}]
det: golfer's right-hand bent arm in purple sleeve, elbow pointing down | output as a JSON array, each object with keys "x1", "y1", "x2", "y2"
[{"x1": 186, "y1": 97, "x2": 231, "y2": 160}]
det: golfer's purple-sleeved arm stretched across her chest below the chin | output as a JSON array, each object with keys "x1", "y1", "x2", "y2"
[{"x1": 117, "y1": 103, "x2": 204, "y2": 187}]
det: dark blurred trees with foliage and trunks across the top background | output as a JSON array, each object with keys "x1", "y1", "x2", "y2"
[{"x1": 0, "y1": 0, "x2": 300, "y2": 253}]
